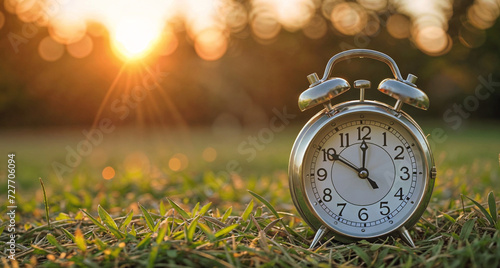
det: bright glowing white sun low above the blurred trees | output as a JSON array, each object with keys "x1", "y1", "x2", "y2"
[{"x1": 112, "y1": 18, "x2": 161, "y2": 60}]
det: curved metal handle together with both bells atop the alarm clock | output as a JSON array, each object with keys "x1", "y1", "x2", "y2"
[{"x1": 299, "y1": 49, "x2": 429, "y2": 112}]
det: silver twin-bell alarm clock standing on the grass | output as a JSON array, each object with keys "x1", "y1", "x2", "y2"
[{"x1": 288, "y1": 49, "x2": 436, "y2": 248}]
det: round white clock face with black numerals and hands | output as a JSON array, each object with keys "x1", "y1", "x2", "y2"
[{"x1": 302, "y1": 112, "x2": 428, "y2": 238}]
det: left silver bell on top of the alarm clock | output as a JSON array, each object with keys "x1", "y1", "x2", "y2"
[{"x1": 299, "y1": 73, "x2": 351, "y2": 111}]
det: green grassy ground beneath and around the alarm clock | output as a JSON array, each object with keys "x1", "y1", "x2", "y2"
[{"x1": 0, "y1": 123, "x2": 500, "y2": 267}]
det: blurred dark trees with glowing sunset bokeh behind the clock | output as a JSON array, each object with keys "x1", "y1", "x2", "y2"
[{"x1": 0, "y1": 0, "x2": 500, "y2": 129}]
